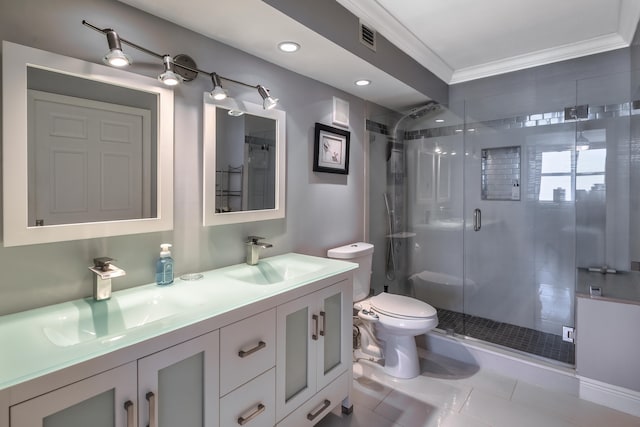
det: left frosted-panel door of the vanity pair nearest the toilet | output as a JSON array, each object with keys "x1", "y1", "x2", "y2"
[{"x1": 276, "y1": 293, "x2": 319, "y2": 419}]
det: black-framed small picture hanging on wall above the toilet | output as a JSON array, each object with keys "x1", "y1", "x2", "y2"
[{"x1": 313, "y1": 123, "x2": 351, "y2": 175}]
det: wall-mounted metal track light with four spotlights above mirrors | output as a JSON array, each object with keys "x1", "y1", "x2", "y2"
[{"x1": 82, "y1": 20, "x2": 278, "y2": 110}]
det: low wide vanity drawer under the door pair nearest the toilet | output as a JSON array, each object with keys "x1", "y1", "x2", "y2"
[{"x1": 278, "y1": 372, "x2": 351, "y2": 427}]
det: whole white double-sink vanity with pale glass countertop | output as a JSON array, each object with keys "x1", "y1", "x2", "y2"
[{"x1": 0, "y1": 253, "x2": 356, "y2": 427}]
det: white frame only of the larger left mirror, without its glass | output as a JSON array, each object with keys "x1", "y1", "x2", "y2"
[{"x1": 2, "y1": 41, "x2": 173, "y2": 246}]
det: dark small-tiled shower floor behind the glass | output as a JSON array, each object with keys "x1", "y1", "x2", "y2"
[{"x1": 436, "y1": 308, "x2": 575, "y2": 365}]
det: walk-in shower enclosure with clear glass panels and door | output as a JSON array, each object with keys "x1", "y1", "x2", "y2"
[{"x1": 367, "y1": 68, "x2": 634, "y2": 365}]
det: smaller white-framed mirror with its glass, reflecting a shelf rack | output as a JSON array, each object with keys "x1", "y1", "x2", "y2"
[{"x1": 203, "y1": 92, "x2": 286, "y2": 226}]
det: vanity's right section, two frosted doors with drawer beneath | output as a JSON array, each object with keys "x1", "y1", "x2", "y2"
[{"x1": 276, "y1": 280, "x2": 353, "y2": 427}]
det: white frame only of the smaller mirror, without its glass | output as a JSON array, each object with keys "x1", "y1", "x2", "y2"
[{"x1": 202, "y1": 92, "x2": 287, "y2": 226}]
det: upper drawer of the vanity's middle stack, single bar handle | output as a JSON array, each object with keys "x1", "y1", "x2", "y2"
[{"x1": 220, "y1": 309, "x2": 276, "y2": 396}]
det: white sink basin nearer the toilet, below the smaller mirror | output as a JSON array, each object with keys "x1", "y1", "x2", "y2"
[{"x1": 225, "y1": 257, "x2": 324, "y2": 285}]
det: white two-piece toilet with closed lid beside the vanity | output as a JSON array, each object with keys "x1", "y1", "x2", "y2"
[{"x1": 327, "y1": 242, "x2": 438, "y2": 378}]
